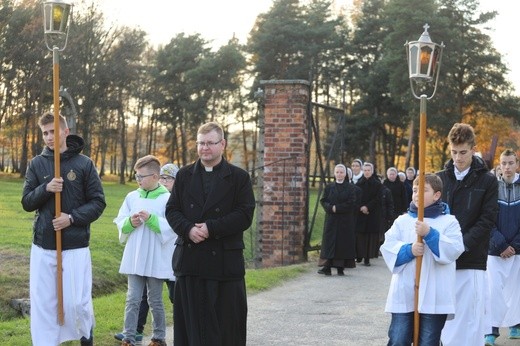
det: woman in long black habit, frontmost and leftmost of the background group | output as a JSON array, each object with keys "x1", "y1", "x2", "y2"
[{"x1": 318, "y1": 164, "x2": 361, "y2": 275}]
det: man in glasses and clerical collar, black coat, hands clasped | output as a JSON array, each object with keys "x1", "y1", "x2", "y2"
[{"x1": 166, "y1": 122, "x2": 255, "y2": 346}]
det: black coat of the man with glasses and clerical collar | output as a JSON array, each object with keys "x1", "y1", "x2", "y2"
[{"x1": 166, "y1": 160, "x2": 255, "y2": 280}]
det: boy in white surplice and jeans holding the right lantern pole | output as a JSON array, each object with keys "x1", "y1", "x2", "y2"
[{"x1": 381, "y1": 174, "x2": 464, "y2": 346}]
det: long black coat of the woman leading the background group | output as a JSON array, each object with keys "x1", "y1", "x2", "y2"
[{"x1": 320, "y1": 182, "x2": 361, "y2": 259}]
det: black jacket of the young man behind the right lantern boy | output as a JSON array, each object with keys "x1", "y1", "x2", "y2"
[{"x1": 437, "y1": 156, "x2": 498, "y2": 270}]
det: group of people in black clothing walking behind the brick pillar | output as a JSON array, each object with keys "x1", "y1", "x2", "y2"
[{"x1": 318, "y1": 159, "x2": 415, "y2": 275}]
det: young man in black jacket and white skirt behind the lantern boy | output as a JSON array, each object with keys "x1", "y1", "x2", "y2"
[{"x1": 437, "y1": 123, "x2": 498, "y2": 346}]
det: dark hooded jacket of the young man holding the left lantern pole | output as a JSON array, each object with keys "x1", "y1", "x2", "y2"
[{"x1": 22, "y1": 135, "x2": 106, "y2": 250}]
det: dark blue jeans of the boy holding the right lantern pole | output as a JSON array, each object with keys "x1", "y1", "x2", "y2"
[{"x1": 388, "y1": 312, "x2": 447, "y2": 346}]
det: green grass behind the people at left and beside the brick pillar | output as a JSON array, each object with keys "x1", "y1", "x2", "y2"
[{"x1": 0, "y1": 173, "x2": 323, "y2": 345}]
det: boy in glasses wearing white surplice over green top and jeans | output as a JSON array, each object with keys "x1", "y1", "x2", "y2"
[{"x1": 114, "y1": 155, "x2": 176, "y2": 346}]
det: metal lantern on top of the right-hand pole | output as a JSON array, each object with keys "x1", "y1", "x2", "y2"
[{"x1": 405, "y1": 24, "x2": 444, "y2": 98}]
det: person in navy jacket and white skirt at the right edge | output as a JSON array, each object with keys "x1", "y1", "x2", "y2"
[{"x1": 485, "y1": 149, "x2": 520, "y2": 346}]
